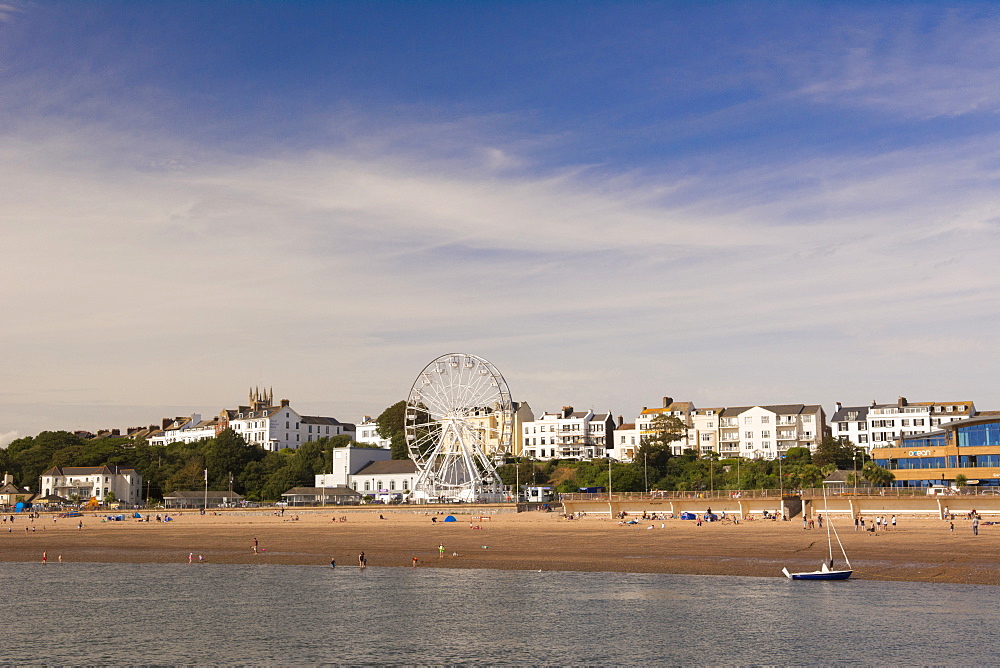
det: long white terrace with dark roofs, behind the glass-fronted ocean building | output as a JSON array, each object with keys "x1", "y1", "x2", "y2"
[{"x1": 830, "y1": 397, "x2": 977, "y2": 451}]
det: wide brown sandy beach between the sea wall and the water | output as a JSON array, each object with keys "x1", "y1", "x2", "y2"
[{"x1": 0, "y1": 508, "x2": 1000, "y2": 584}]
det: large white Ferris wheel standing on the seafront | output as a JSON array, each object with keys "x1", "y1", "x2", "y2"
[{"x1": 406, "y1": 353, "x2": 514, "y2": 501}]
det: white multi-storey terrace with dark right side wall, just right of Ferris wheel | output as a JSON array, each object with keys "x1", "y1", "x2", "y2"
[{"x1": 521, "y1": 406, "x2": 615, "y2": 459}]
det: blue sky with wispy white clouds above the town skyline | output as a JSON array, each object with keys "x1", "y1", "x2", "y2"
[{"x1": 0, "y1": 0, "x2": 1000, "y2": 445}]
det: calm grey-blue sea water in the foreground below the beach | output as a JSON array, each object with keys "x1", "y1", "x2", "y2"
[{"x1": 0, "y1": 563, "x2": 1000, "y2": 665}]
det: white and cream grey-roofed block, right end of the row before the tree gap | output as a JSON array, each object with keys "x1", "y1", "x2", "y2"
[{"x1": 719, "y1": 404, "x2": 826, "y2": 459}]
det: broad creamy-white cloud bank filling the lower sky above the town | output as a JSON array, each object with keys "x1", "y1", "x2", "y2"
[{"x1": 0, "y1": 99, "x2": 1000, "y2": 433}]
